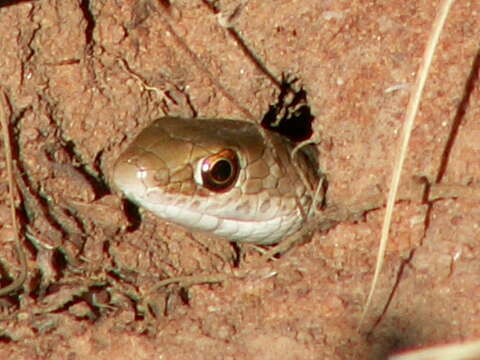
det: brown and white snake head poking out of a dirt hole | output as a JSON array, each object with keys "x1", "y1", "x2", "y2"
[{"x1": 112, "y1": 116, "x2": 321, "y2": 245}]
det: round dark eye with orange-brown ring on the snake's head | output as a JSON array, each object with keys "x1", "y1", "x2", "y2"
[{"x1": 201, "y1": 149, "x2": 240, "y2": 192}]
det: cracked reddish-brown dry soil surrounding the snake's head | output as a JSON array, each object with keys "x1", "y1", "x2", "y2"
[{"x1": 0, "y1": 0, "x2": 480, "y2": 360}]
